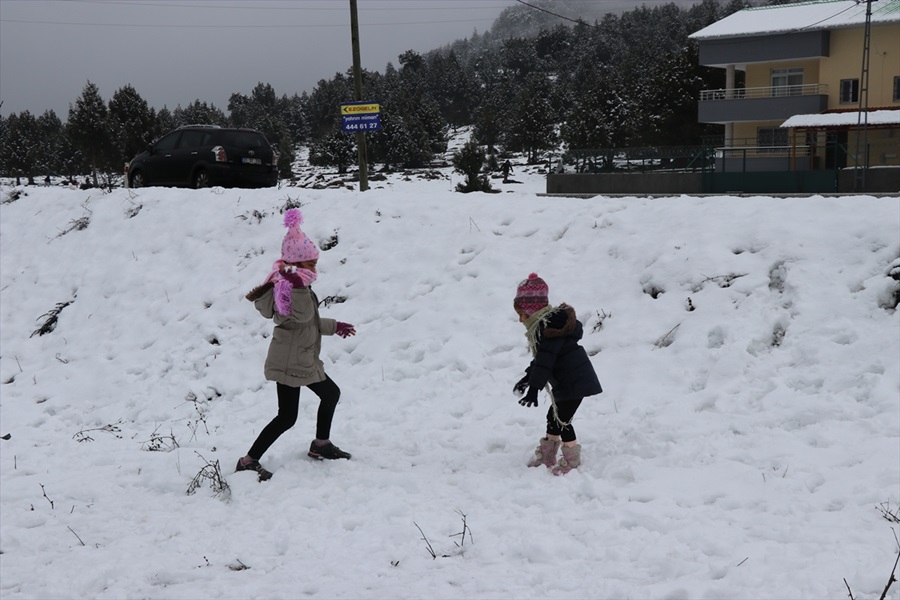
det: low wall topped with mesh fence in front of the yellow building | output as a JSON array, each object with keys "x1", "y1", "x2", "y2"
[{"x1": 553, "y1": 137, "x2": 900, "y2": 193}]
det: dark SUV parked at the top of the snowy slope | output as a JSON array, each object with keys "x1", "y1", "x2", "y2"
[{"x1": 128, "y1": 125, "x2": 278, "y2": 188}]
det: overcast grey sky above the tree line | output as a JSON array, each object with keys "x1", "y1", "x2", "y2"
[{"x1": 0, "y1": 0, "x2": 514, "y2": 121}]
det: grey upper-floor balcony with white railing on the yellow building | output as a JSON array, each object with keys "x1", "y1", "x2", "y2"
[{"x1": 697, "y1": 83, "x2": 828, "y2": 123}]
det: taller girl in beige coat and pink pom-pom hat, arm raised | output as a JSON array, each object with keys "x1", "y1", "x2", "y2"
[{"x1": 235, "y1": 208, "x2": 356, "y2": 481}]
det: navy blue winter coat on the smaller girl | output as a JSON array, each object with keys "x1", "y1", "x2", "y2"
[{"x1": 526, "y1": 304, "x2": 603, "y2": 402}]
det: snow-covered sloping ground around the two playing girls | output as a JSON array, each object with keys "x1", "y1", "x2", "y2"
[{"x1": 0, "y1": 166, "x2": 900, "y2": 600}]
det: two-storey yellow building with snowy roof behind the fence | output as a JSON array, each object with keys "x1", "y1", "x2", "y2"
[{"x1": 690, "y1": 0, "x2": 900, "y2": 191}]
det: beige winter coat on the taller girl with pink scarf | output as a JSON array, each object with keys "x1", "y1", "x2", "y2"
[{"x1": 247, "y1": 283, "x2": 337, "y2": 387}]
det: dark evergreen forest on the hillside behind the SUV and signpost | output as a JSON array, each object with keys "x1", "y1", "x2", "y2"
[{"x1": 0, "y1": 0, "x2": 785, "y2": 185}]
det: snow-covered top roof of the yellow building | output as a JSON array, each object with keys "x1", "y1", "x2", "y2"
[{"x1": 689, "y1": 0, "x2": 900, "y2": 40}]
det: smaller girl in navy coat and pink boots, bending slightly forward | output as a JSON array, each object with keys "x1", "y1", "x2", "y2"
[{"x1": 513, "y1": 273, "x2": 603, "y2": 475}]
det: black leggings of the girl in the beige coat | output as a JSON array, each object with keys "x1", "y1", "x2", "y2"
[{"x1": 247, "y1": 375, "x2": 341, "y2": 460}]
